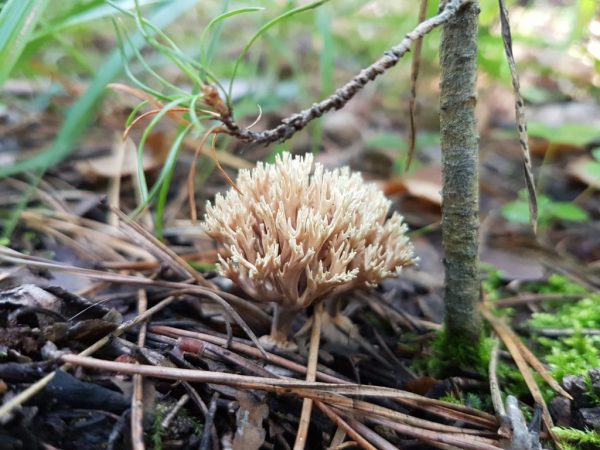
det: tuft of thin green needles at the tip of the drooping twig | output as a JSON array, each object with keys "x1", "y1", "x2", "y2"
[{"x1": 106, "y1": 0, "x2": 327, "y2": 235}]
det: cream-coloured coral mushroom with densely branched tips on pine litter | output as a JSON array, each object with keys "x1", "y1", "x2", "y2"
[{"x1": 203, "y1": 153, "x2": 413, "y2": 342}]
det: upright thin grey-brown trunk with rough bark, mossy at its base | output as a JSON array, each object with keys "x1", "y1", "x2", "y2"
[{"x1": 440, "y1": 1, "x2": 480, "y2": 367}]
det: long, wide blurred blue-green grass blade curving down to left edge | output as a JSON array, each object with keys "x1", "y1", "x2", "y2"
[{"x1": 0, "y1": 0, "x2": 195, "y2": 177}]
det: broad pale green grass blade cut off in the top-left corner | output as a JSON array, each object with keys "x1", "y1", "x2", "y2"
[{"x1": 0, "y1": 0, "x2": 48, "y2": 88}]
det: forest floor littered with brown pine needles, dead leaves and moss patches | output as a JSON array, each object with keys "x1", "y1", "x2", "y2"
[{"x1": 0, "y1": 2, "x2": 600, "y2": 450}]
